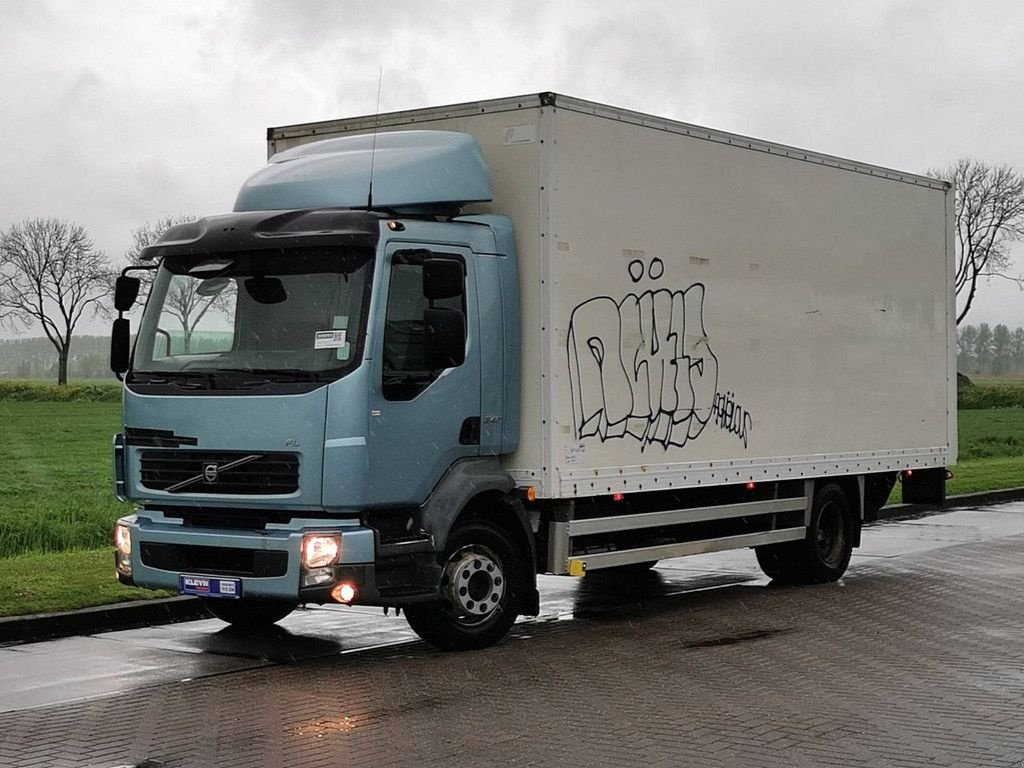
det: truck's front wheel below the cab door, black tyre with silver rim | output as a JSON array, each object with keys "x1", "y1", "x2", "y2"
[{"x1": 406, "y1": 520, "x2": 528, "y2": 650}]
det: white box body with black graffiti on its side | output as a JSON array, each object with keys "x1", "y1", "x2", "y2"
[{"x1": 268, "y1": 94, "x2": 956, "y2": 499}]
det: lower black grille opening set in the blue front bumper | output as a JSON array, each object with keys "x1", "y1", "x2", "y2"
[{"x1": 140, "y1": 542, "x2": 288, "y2": 578}]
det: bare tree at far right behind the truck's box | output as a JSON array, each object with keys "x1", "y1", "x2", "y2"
[{"x1": 929, "y1": 158, "x2": 1024, "y2": 325}]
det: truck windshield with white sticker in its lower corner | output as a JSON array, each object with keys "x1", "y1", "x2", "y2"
[{"x1": 132, "y1": 248, "x2": 373, "y2": 387}]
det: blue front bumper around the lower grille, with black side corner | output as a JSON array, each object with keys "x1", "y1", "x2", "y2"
[{"x1": 118, "y1": 510, "x2": 440, "y2": 606}]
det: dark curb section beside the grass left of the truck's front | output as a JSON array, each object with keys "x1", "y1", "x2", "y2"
[{"x1": 0, "y1": 597, "x2": 210, "y2": 644}]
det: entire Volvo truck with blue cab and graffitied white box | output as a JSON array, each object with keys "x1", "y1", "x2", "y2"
[{"x1": 111, "y1": 92, "x2": 956, "y2": 649}]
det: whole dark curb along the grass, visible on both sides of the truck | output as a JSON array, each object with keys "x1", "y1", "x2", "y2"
[{"x1": 6, "y1": 487, "x2": 1024, "y2": 644}]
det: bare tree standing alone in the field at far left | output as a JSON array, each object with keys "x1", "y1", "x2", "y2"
[{"x1": 0, "y1": 218, "x2": 111, "y2": 384}]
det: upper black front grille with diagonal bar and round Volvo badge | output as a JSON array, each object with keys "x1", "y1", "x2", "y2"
[{"x1": 141, "y1": 451, "x2": 299, "y2": 495}]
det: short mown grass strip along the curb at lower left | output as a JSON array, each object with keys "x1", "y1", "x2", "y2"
[{"x1": 0, "y1": 547, "x2": 173, "y2": 616}]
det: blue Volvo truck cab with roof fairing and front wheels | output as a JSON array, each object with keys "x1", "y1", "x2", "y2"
[{"x1": 114, "y1": 131, "x2": 538, "y2": 647}]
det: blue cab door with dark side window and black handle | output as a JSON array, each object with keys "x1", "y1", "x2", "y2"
[{"x1": 368, "y1": 244, "x2": 480, "y2": 506}]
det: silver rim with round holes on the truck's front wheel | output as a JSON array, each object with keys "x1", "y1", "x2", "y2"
[{"x1": 441, "y1": 545, "x2": 506, "y2": 624}]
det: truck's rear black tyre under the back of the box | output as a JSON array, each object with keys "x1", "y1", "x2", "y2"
[{"x1": 755, "y1": 482, "x2": 855, "y2": 584}]
